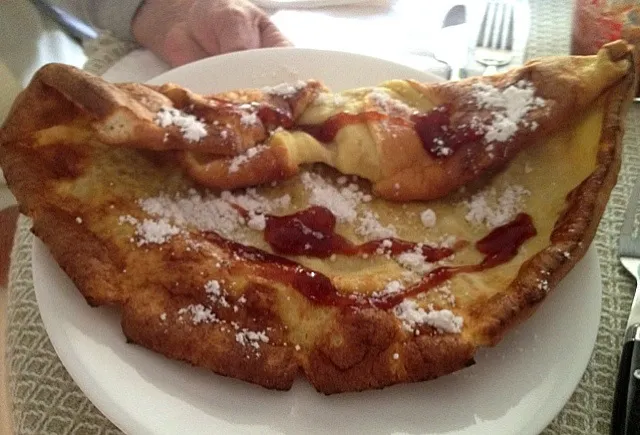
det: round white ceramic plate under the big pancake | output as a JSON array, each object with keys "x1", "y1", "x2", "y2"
[{"x1": 33, "y1": 49, "x2": 602, "y2": 435}]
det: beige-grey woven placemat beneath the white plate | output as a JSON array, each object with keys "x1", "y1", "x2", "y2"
[{"x1": 7, "y1": 0, "x2": 640, "y2": 435}]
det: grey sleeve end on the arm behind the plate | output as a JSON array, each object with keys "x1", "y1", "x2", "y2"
[{"x1": 46, "y1": 0, "x2": 143, "y2": 41}]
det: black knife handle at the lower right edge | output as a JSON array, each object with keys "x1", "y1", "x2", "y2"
[{"x1": 611, "y1": 325, "x2": 640, "y2": 435}]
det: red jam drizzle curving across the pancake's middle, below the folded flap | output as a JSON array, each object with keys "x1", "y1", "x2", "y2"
[{"x1": 219, "y1": 207, "x2": 537, "y2": 310}]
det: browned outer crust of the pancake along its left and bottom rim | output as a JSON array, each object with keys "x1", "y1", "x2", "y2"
[{"x1": 0, "y1": 43, "x2": 635, "y2": 394}]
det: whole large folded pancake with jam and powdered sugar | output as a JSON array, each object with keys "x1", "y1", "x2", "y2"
[{"x1": 0, "y1": 41, "x2": 636, "y2": 393}]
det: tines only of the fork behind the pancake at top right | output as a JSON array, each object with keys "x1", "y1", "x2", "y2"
[{"x1": 476, "y1": 1, "x2": 514, "y2": 50}]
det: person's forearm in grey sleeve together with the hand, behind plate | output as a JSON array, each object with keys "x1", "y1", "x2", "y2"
[{"x1": 46, "y1": 0, "x2": 291, "y2": 66}]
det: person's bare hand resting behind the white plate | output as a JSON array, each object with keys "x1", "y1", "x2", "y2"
[{"x1": 131, "y1": 0, "x2": 291, "y2": 66}]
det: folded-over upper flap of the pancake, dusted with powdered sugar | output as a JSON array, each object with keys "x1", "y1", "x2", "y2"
[{"x1": 2, "y1": 44, "x2": 628, "y2": 201}]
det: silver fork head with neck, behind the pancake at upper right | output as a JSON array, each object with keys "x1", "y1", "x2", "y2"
[{"x1": 474, "y1": 1, "x2": 514, "y2": 75}]
